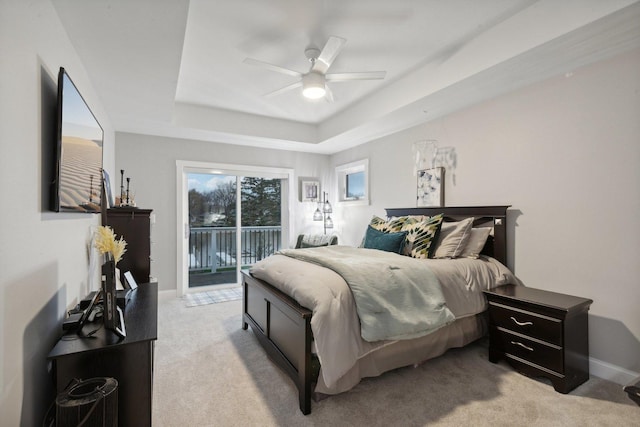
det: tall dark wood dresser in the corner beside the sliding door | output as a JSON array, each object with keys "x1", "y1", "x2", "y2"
[{"x1": 107, "y1": 208, "x2": 153, "y2": 283}]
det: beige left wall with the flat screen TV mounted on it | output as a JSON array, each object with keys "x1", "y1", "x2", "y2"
[{"x1": 0, "y1": 0, "x2": 114, "y2": 426}]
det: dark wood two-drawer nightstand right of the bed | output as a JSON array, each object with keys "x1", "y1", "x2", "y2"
[{"x1": 484, "y1": 285, "x2": 593, "y2": 393}]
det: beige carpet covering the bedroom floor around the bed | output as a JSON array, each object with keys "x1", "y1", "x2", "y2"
[{"x1": 153, "y1": 295, "x2": 640, "y2": 426}]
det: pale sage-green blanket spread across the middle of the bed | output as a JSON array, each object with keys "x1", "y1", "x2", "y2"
[{"x1": 279, "y1": 246, "x2": 455, "y2": 342}]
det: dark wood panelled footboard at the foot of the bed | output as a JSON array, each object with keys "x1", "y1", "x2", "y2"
[{"x1": 242, "y1": 272, "x2": 315, "y2": 415}]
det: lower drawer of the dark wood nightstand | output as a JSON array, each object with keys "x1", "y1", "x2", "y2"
[{"x1": 490, "y1": 329, "x2": 564, "y2": 373}]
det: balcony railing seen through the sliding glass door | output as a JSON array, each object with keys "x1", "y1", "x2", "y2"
[{"x1": 189, "y1": 226, "x2": 282, "y2": 273}]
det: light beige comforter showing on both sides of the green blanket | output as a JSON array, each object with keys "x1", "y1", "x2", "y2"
[{"x1": 251, "y1": 249, "x2": 519, "y2": 387}]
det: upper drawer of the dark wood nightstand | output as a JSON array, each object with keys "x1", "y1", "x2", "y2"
[{"x1": 489, "y1": 302, "x2": 562, "y2": 346}]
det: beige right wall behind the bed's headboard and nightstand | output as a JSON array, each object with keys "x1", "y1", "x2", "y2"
[{"x1": 331, "y1": 47, "x2": 640, "y2": 382}]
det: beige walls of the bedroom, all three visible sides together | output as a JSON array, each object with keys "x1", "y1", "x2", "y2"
[{"x1": 0, "y1": 0, "x2": 640, "y2": 425}]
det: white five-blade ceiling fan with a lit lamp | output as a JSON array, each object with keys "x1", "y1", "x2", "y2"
[{"x1": 243, "y1": 36, "x2": 386, "y2": 101}]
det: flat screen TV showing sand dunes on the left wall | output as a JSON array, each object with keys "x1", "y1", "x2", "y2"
[{"x1": 51, "y1": 67, "x2": 104, "y2": 213}]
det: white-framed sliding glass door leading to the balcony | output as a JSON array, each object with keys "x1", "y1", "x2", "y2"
[{"x1": 178, "y1": 162, "x2": 292, "y2": 292}]
